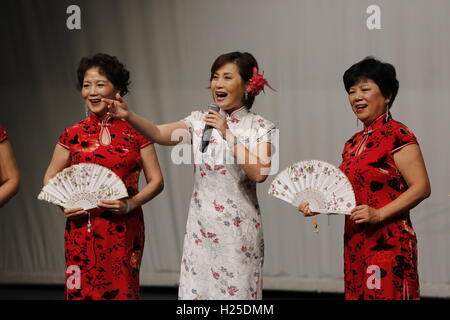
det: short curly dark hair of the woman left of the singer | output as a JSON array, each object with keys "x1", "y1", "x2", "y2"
[{"x1": 77, "y1": 53, "x2": 130, "y2": 97}]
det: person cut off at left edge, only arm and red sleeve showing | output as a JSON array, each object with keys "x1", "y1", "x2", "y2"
[{"x1": 0, "y1": 126, "x2": 20, "y2": 208}]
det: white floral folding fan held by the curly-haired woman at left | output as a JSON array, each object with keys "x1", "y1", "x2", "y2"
[{"x1": 38, "y1": 163, "x2": 128, "y2": 210}]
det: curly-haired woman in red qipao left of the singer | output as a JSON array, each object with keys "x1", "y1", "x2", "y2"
[{"x1": 44, "y1": 54, "x2": 163, "y2": 300}]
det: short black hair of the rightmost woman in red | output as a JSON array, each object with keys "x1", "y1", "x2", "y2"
[{"x1": 343, "y1": 57, "x2": 399, "y2": 109}]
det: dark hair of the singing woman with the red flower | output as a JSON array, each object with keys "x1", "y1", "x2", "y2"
[{"x1": 209, "y1": 51, "x2": 258, "y2": 109}]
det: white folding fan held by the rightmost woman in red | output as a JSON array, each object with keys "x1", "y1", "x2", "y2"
[{"x1": 268, "y1": 160, "x2": 356, "y2": 214}]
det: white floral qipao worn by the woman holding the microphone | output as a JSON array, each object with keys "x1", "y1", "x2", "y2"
[{"x1": 179, "y1": 107, "x2": 274, "y2": 299}]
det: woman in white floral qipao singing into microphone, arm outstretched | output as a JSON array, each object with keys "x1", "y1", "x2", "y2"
[{"x1": 103, "y1": 52, "x2": 275, "y2": 299}]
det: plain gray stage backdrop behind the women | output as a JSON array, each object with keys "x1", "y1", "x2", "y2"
[{"x1": 0, "y1": 0, "x2": 450, "y2": 297}]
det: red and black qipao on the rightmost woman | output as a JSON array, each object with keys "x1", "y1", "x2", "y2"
[{"x1": 340, "y1": 115, "x2": 420, "y2": 300}]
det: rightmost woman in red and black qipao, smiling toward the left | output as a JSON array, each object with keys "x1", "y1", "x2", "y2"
[{"x1": 300, "y1": 57, "x2": 431, "y2": 300}]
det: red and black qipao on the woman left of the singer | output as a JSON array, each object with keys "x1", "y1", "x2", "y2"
[{"x1": 58, "y1": 114, "x2": 151, "y2": 300}]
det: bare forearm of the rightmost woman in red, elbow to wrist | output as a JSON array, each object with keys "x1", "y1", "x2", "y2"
[{"x1": 380, "y1": 185, "x2": 431, "y2": 220}]
